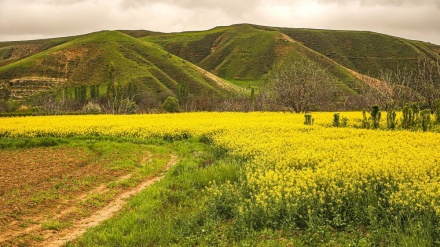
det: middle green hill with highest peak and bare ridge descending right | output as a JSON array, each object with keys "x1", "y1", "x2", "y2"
[{"x1": 142, "y1": 24, "x2": 361, "y2": 91}]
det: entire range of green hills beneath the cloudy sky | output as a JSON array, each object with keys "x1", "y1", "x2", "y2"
[{"x1": 0, "y1": 24, "x2": 440, "y2": 112}]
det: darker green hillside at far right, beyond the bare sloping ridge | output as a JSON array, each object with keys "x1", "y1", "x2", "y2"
[{"x1": 280, "y1": 28, "x2": 440, "y2": 76}]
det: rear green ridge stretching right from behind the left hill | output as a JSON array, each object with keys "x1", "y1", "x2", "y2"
[{"x1": 141, "y1": 24, "x2": 440, "y2": 89}]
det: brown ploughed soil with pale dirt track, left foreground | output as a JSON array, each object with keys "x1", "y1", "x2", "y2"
[{"x1": 0, "y1": 147, "x2": 175, "y2": 246}]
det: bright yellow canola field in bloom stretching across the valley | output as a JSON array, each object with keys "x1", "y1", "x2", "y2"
[{"x1": 0, "y1": 112, "x2": 440, "y2": 220}]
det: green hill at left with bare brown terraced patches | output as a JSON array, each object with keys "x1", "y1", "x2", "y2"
[{"x1": 0, "y1": 31, "x2": 237, "y2": 98}]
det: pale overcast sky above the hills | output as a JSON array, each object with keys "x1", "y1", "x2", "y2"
[{"x1": 0, "y1": 0, "x2": 440, "y2": 44}]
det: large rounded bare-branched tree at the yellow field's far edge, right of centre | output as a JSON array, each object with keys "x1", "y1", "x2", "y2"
[{"x1": 267, "y1": 56, "x2": 334, "y2": 113}]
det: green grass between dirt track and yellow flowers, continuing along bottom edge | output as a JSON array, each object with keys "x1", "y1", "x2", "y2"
[{"x1": 68, "y1": 138, "x2": 436, "y2": 246}]
